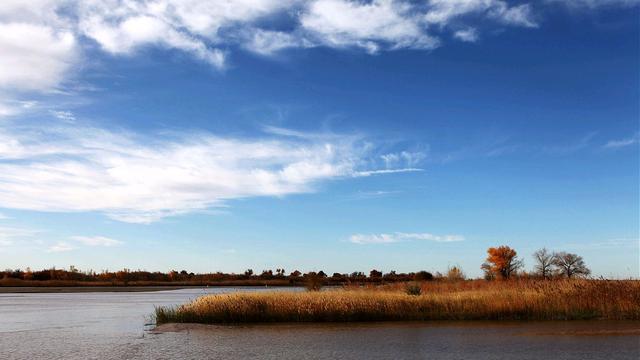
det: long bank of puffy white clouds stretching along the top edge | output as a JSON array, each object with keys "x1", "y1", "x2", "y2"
[{"x1": 0, "y1": 0, "x2": 536, "y2": 94}]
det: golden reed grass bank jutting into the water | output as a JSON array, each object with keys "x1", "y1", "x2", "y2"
[{"x1": 156, "y1": 280, "x2": 640, "y2": 324}]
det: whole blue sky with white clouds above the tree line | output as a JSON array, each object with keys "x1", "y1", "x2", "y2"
[{"x1": 0, "y1": 0, "x2": 640, "y2": 278}]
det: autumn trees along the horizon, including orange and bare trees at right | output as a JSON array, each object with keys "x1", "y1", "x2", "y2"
[{"x1": 0, "y1": 245, "x2": 591, "y2": 285}]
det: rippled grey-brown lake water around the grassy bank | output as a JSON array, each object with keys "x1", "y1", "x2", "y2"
[{"x1": 0, "y1": 288, "x2": 640, "y2": 360}]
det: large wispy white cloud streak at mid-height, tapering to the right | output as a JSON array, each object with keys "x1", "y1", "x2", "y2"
[{"x1": 0, "y1": 123, "x2": 419, "y2": 223}]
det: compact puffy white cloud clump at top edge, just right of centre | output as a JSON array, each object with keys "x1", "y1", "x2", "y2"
[{"x1": 300, "y1": 0, "x2": 439, "y2": 53}]
